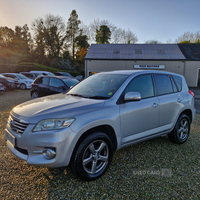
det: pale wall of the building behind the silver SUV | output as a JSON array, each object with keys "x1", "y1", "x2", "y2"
[{"x1": 85, "y1": 60, "x2": 200, "y2": 87}]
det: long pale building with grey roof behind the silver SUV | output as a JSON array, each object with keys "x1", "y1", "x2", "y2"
[{"x1": 85, "y1": 44, "x2": 200, "y2": 87}]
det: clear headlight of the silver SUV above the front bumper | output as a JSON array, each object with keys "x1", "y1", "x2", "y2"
[{"x1": 33, "y1": 118, "x2": 75, "y2": 132}]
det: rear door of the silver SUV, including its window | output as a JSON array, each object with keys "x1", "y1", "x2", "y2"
[{"x1": 154, "y1": 74, "x2": 184, "y2": 130}]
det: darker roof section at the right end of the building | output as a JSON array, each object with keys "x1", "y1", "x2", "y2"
[{"x1": 178, "y1": 43, "x2": 200, "y2": 60}]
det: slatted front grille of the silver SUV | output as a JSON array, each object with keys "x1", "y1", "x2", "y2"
[{"x1": 8, "y1": 115, "x2": 29, "y2": 134}]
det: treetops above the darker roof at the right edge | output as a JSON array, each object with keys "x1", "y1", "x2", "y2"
[{"x1": 175, "y1": 31, "x2": 200, "y2": 43}]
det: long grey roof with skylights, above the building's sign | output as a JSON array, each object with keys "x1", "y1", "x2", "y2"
[{"x1": 85, "y1": 44, "x2": 186, "y2": 60}]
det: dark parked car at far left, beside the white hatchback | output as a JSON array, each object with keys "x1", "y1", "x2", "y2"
[{"x1": 0, "y1": 74, "x2": 19, "y2": 91}]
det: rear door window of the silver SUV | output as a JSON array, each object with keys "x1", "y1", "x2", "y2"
[{"x1": 154, "y1": 74, "x2": 173, "y2": 95}]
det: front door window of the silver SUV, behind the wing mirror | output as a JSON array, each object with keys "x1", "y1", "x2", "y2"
[{"x1": 125, "y1": 74, "x2": 154, "y2": 99}]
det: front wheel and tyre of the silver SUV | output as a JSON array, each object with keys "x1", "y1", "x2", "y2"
[{"x1": 70, "y1": 132, "x2": 113, "y2": 181}]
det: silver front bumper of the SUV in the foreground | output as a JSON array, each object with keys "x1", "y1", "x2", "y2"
[{"x1": 5, "y1": 124, "x2": 75, "y2": 167}]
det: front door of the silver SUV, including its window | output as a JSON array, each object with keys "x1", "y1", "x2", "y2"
[{"x1": 120, "y1": 74, "x2": 159, "y2": 144}]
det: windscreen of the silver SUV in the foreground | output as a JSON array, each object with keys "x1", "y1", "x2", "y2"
[{"x1": 67, "y1": 74, "x2": 128, "y2": 99}]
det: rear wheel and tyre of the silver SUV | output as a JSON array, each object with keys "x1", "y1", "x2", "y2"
[{"x1": 168, "y1": 114, "x2": 190, "y2": 144}]
